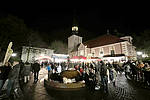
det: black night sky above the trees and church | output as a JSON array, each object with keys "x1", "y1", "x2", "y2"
[{"x1": 0, "y1": 5, "x2": 150, "y2": 40}]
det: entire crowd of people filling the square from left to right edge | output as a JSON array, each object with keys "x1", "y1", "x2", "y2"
[{"x1": 0, "y1": 58, "x2": 150, "y2": 97}]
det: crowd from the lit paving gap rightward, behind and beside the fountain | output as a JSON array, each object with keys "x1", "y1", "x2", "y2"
[{"x1": 46, "y1": 60, "x2": 150, "y2": 93}]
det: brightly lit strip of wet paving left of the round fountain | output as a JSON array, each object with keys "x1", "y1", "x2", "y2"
[{"x1": 23, "y1": 68, "x2": 53, "y2": 100}]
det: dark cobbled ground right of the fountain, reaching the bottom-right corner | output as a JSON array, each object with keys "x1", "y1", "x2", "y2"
[{"x1": 109, "y1": 75, "x2": 150, "y2": 100}]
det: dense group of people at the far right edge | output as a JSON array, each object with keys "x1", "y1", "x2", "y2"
[{"x1": 124, "y1": 61, "x2": 150, "y2": 86}]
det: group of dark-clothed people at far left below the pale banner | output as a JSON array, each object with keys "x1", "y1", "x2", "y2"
[{"x1": 0, "y1": 60, "x2": 21, "y2": 98}]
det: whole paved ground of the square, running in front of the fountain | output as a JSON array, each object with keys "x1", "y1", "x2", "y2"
[{"x1": 24, "y1": 68, "x2": 150, "y2": 100}]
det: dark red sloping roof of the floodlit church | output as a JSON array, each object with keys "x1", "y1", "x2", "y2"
[{"x1": 83, "y1": 34, "x2": 126, "y2": 48}]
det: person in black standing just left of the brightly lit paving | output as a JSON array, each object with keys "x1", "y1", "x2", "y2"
[{"x1": 32, "y1": 62, "x2": 40, "y2": 83}]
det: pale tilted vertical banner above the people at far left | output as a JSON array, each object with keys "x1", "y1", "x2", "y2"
[{"x1": 3, "y1": 42, "x2": 13, "y2": 65}]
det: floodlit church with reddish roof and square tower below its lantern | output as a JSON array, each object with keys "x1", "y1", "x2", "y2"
[{"x1": 68, "y1": 26, "x2": 136, "y2": 61}]
